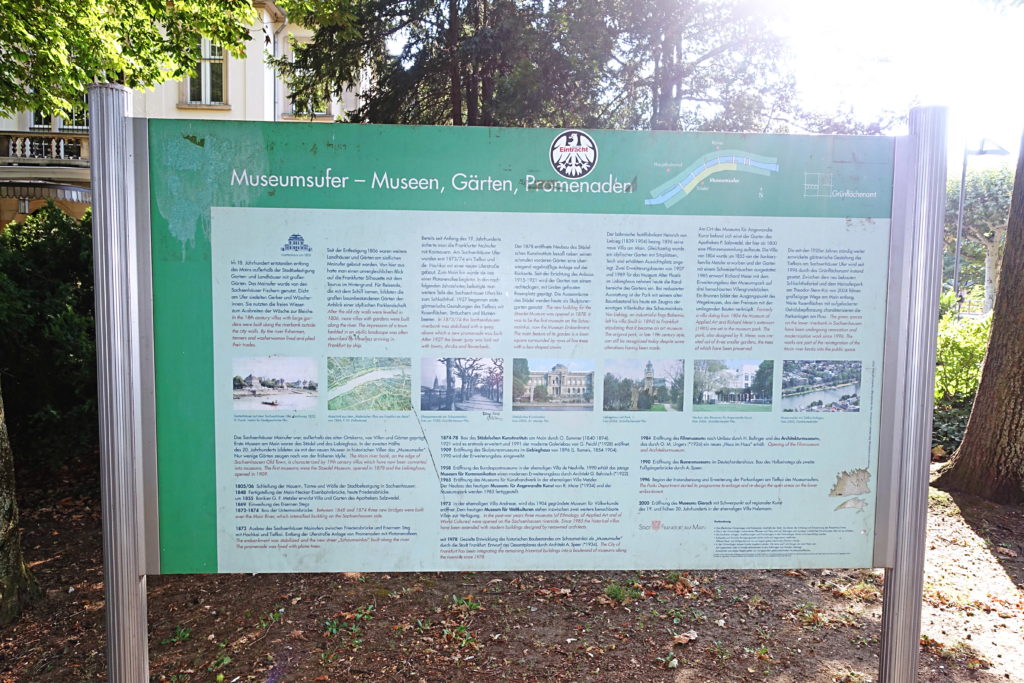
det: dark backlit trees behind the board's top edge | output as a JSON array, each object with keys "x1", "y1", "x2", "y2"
[{"x1": 274, "y1": 0, "x2": 795, "y2": 131}]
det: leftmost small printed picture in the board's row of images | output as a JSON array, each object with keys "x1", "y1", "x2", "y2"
[{"x1": 231, "y1": 355, "x2": 319, "y2": 411}]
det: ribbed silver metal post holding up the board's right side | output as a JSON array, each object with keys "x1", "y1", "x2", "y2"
[{"x1": 879, "y1": 106, "x2": 946, "y2": 683}]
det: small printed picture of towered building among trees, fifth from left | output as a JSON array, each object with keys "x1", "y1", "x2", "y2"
[{"x1": 602, "y1": 358, "x2": 684, "y2": 413}]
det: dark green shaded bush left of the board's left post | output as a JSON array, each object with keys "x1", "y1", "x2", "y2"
[{"x1": 0, "y1": 205, "x2": 98, "y2": 465}]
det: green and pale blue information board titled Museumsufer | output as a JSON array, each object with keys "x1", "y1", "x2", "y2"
[{"x1": 147, "y1": 120, "x2": 894, "y2": 572}]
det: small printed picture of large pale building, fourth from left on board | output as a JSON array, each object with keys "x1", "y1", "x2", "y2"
[{"x1": 512, "y1": 358, "x2": 594, "y2": 411}]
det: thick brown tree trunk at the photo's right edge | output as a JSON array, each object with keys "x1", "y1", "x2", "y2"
[{"x1": 935, "y1": 140, "x2": 1024, "y2": 503}]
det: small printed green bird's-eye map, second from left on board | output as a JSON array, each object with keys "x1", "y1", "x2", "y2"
[{"x1": 327, "y1": 357, "x2": 413, "y2": 411}]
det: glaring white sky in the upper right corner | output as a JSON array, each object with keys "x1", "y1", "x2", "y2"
[{"x1": 771, "y1": 0, "x2": 1024, "y2": 171}]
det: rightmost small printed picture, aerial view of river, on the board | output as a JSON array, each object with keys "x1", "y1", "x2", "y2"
[{"x1": 781, "y1": 360, "x2": 862, "y2": 413}]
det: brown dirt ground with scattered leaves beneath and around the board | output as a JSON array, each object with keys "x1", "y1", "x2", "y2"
[{"x1": 0, "y1": 464, "x2": 1024, "y2": 683}]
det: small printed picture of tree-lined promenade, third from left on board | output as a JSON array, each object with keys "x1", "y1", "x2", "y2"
[{"x1": 420, "y1": 358, "x2": 505, "y2": 411}]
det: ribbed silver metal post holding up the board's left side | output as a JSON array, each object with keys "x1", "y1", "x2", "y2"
[{"x1": 89, "y1": 83, "x2": 150, "y2": 683}]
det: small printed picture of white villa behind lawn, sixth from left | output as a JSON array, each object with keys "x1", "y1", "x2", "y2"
[{"x1": 693, "y1": 359, "x2": 775, "y2": 413}]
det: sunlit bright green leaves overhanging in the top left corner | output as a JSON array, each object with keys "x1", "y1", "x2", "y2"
[{"x1": 0, "y1": 0, "x2": 255, "y2": 115}]
